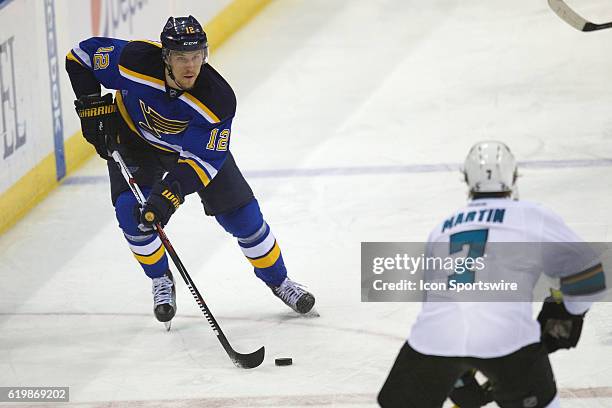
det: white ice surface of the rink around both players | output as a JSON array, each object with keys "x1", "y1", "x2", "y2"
[{"x1": 0, "y1": 0, "x2": 612, "y2": 408}]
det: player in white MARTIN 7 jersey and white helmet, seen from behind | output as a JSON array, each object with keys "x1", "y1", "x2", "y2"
[{"x1": 378, "y1": 142, "x2": 605, "y2": 408}]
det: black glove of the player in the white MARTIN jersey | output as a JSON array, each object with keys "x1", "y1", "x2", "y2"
[{"x1": 538, "y1": 296, "x2": 586, "y2": 353}]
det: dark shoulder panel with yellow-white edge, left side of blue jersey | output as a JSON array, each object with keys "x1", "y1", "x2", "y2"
[{"x1": 119, "y1": 40, "x2": 165, "y2": 90}]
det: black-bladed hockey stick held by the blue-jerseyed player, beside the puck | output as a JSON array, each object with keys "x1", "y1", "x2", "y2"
[{"x1": 111, "y1": 151, "x2": 265, "y2": 368}]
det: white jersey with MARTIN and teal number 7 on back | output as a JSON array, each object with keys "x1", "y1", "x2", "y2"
[{"x1": 408, "y1": 198, "x2": 605, "y2": 358}]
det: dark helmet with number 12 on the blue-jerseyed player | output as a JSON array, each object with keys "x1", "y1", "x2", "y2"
[{"x1": 160, "y1": 16, "x2": 208, "y2": 51}]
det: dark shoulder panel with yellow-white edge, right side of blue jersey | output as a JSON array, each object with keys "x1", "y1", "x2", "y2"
[{"x1": 181, "y1": 64, "x2": 236, "y2": 123}]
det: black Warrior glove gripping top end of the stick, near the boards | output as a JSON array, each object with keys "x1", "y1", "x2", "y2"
[{"x1": 74, "y1": 94, "x2": 118, "y2": 160}]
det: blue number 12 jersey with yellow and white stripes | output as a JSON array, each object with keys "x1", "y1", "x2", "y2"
[{"x1": 66, "y1": 37, "x2": 236, "y2": 194}]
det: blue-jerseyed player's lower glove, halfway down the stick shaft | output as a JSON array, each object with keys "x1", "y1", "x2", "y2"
[{"x1": 140, "y1": 180, "x2": 185, "y2": 228}]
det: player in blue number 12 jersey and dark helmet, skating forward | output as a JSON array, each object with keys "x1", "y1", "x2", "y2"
[{"x1": 66, "y1": 16, "x2": 315, "y2": 322}]
